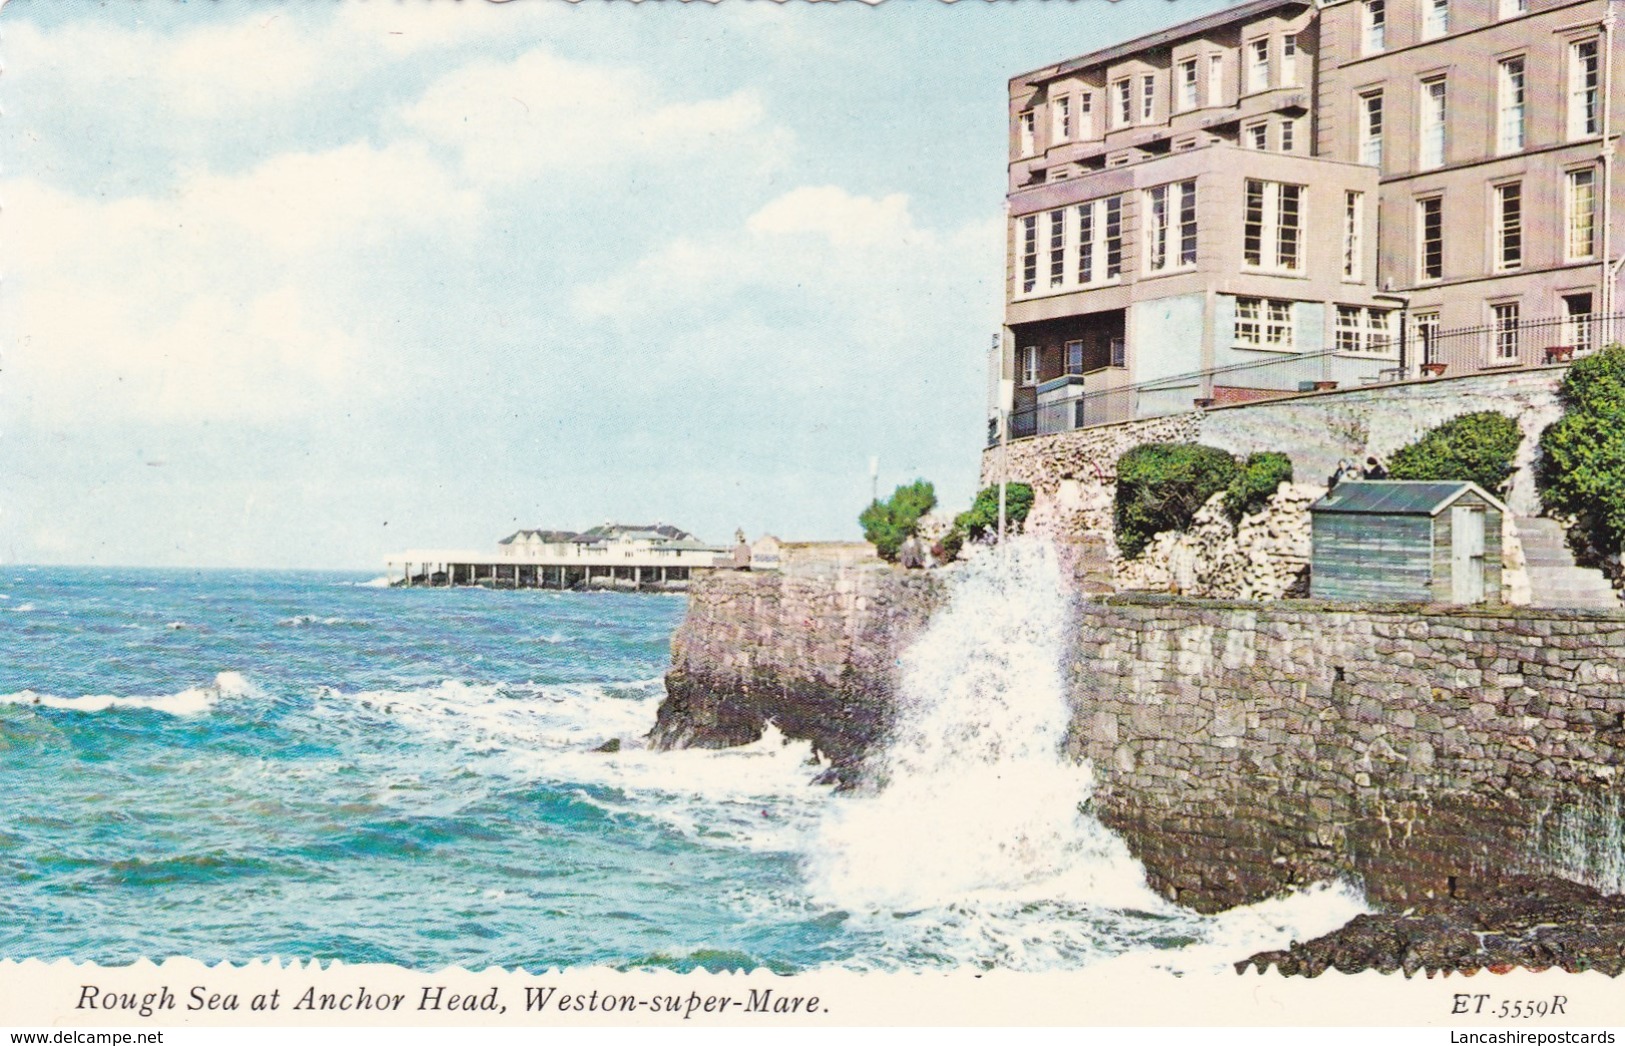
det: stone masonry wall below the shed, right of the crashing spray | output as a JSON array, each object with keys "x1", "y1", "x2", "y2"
[{"x1": 1068, "y1": 594, "x2": 1625, "y2": 910}]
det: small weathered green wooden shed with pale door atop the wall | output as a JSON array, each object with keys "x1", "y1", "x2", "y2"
[{"x1": 1310, "y1": 479, "x2": 1506, "y2": 603}]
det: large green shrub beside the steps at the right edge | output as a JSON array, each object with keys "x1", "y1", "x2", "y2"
[{"x1": 1537, "y1": 344, "x2": 1625, "y2": 555}]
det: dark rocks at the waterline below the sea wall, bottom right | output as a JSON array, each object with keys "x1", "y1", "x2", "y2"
[{"x1": 1235, "y1": 875, "x2": 1625, "y2": 978}]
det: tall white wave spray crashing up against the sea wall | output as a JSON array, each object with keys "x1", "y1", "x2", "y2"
[{"x1": 808, "y1": 538, "x2": 1167, "y2": 911}]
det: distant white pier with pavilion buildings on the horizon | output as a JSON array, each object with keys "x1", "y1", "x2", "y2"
[{"x1": 385, "y1": 523, "x2": 734, "y2": 591}]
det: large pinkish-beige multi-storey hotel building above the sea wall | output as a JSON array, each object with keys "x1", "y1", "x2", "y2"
[{"x1": 995, "y1": 0, "x2": 1625, "y2": 437}]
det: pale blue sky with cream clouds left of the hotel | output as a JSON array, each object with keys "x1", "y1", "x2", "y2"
[{"x1": 0, "y1": 0, "x2": 1220, "y2": 570}]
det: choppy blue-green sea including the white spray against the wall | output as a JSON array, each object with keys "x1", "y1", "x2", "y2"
[{"x1": 0, "y1": 542, "x2": 1363, "y2": 973}]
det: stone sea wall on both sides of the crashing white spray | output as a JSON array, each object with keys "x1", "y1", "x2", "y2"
[{"x1": 652, "y1": 555, "x2": 1625, "y2": 910}]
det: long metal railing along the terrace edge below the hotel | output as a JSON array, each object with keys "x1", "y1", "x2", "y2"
[{"x1": 988, "y1": 313, "x2": 1625, "y2": 447}]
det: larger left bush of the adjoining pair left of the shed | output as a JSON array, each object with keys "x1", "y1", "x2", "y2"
[{"x1": 1113, "y1": 443, "x2": 1242, "y2": 559}]
